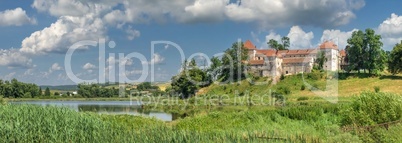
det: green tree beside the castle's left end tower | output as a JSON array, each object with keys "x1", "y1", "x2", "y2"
[{"x1": 221, "y1": 42, "x2": 248, "y2": 82}]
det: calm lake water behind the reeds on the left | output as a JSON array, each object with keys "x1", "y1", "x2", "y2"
[{"x1": 11, "y1": 101, "x2": 173, "y2": 121}]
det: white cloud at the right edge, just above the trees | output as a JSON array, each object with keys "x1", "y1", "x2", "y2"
[{"x1": 376, "y1": 13, "x2": 402, "y2": 50}]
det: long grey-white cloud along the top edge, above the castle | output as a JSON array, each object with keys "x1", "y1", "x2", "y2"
[{"x1": 225, "y1": 0, "x2": 365, "y2": 28}]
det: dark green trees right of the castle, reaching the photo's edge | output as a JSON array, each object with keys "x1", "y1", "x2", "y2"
[{"x1": 345, "y1": 28, "x2": 402, "y2": 75}]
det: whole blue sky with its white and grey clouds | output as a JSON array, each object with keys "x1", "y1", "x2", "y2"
[{"x1": 0, "y1": 0, "x2": 402, "y2": 85}]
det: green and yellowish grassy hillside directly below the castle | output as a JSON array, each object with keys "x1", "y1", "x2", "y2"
[{"x1": 197, "y1": 73, "x2": 402, "y2": 99}]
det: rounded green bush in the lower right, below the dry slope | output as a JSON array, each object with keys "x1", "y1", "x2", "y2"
[{"x1": 342, "y1": 92, "x2": 402, "y2": 126}]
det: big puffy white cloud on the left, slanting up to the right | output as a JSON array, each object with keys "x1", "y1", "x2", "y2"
[{"x1": 20, "y1": 14, "x2": 106, "y2": 55}]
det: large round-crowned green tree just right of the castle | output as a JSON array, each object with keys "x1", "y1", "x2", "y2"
[{"x1": 346, "y1": 29, "x2": 386, "y2": 74}]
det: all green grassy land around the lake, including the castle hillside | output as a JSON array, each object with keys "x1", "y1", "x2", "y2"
[{"x1": 0, "y1": 74, "x2": 402, "y2": 142}]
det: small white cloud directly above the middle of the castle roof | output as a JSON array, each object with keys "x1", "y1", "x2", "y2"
[{"x1": 288, "y1": 26, "x2": 314, "y2": 49}]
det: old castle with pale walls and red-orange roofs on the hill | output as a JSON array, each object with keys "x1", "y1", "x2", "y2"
[{"x1": 244, "y1": 40, "x2": 347, "y2": 77}]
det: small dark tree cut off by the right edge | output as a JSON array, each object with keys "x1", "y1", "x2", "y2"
[{"x1": 388, "y1": 40, "x2": 402, "y2": 75}]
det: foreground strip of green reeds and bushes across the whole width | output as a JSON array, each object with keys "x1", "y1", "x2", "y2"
[{"x1": 0, "y1": 92, "x2": 402, "y2": 142}]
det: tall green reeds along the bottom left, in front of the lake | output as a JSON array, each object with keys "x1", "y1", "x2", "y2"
[{"x1": 0, "y1": 105, "x2": 328, "y2": 142}]
